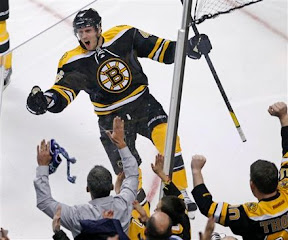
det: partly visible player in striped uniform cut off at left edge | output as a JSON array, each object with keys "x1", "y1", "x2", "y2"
[{"x1": 0, "y1": 0, "x2": 12, "y2": 88}]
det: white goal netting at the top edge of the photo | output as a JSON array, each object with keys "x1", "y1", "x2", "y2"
[{"x1": 194, "y1": 0, "x2": 262, "y2": 24}]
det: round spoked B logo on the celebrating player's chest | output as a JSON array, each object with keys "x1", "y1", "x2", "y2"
[{"x1": 97, "y1": 58, "x2": 132, "y2": 93}]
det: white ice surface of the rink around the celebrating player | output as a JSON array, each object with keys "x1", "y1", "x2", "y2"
[{"x1": 0, "y1": 0, "x2": 288, "y2": 240}]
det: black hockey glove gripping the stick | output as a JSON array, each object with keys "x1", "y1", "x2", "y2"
[{"x1": 187, "y1": 34, "x2": 212, "y2": 59}]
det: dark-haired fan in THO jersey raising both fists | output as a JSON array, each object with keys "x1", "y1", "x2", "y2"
[{"x1": 191, "y1": 102, "x2": 288, "y2": 240}]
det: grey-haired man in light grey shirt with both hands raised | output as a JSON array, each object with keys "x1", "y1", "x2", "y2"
[{"x1": 34, "y1": 117, "x2": 138, "y2": 238}]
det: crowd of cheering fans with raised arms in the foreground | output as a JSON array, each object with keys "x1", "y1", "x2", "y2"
[{"x1": 1, "y1": 102, "x2": 288, "y2": 240}]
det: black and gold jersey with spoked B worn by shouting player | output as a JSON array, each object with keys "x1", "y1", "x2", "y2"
[{"x1": 45, "y1": 25, "x2": 176, "y2": 115}]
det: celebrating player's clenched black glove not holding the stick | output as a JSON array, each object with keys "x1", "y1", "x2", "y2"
[{"x1": 26, "y1": 86, "x2": 48, "y2": 115}]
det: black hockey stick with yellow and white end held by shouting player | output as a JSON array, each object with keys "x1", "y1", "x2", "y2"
[{"x1": 181, "y1": 0, "x2": 247, "y2": 142}]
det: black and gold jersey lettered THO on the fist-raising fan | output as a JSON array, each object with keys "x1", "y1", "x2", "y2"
[{"x1": 192, "y1": 127, "x2": 288, "y2": 240}]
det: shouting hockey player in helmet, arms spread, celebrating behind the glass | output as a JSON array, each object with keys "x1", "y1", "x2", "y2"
[{"x1": 27, "y1": 8, "x2": 212, "y2": 217}]
